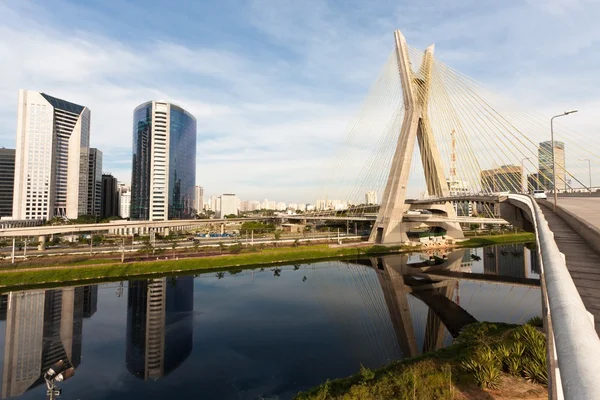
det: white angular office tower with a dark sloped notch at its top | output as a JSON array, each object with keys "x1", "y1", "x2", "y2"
[{"x1": 13, "y1": 90, "x2": 90, "y2": 220}]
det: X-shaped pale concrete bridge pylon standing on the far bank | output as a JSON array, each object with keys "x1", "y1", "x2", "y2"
[{"x1": 369, "y1": 30, "x2": 463, "y2": 244}]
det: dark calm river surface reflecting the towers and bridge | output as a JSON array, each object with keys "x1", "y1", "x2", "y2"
[{"x1": 0, "y1": 245, "x2": 541, "y2": 400}]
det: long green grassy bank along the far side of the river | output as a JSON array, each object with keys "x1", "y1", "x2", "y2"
[{"x1": 0, "y1": 233, "x2": 533, "y2": 291}]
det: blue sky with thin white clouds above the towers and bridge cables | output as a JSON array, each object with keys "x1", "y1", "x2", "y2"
[{"x1": 0, "y1": 0, "x2": 600, "y2": 202}]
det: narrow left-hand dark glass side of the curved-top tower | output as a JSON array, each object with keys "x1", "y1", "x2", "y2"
[{"x1": 129, "y1": 102, "x2": 152, "y2": 220}]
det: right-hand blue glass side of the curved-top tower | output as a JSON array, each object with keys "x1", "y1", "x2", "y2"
[{"x1": 169, "y1": 105, "x2": 196, "y2": 219}]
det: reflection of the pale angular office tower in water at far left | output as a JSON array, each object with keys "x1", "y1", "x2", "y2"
[{"x1": 0, "y1": 285, "x2": 98, "y2": 398}]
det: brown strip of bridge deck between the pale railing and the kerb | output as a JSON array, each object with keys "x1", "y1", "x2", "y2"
[{"x1": 541, "y1": 204, "x2": 600, "y2": 334}]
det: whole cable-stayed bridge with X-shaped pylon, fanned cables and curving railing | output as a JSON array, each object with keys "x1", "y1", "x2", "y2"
[{"x1": 312, "y1": 31, "x2": 600, "y2": 399}]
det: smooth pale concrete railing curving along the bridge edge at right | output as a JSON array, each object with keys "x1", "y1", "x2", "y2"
[{"x1": 510, "y1": 195, "x2": 600, "y2": 400}]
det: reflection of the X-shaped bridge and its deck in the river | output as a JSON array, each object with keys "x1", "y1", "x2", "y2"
[{"x1": 315, "y1": 245, "x2": 541, "y2": 364}]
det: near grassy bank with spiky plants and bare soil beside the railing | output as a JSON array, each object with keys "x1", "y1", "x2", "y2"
[{"x1": 296, "y1": 322, "x2": 547, "y2": 400}]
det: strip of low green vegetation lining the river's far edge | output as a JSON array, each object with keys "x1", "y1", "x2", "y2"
[{"x1": 0, "y1": 233, "x2": 531, "y2": 288}]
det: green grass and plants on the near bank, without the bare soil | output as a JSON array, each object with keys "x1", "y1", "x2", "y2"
[{"x1": 295, "y1": 322, "x2": 545, "y2": 400}]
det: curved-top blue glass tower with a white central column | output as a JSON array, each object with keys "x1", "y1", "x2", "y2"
[{"x1": 131, "y1": 101, "x2": 196, "y2": 221}]
